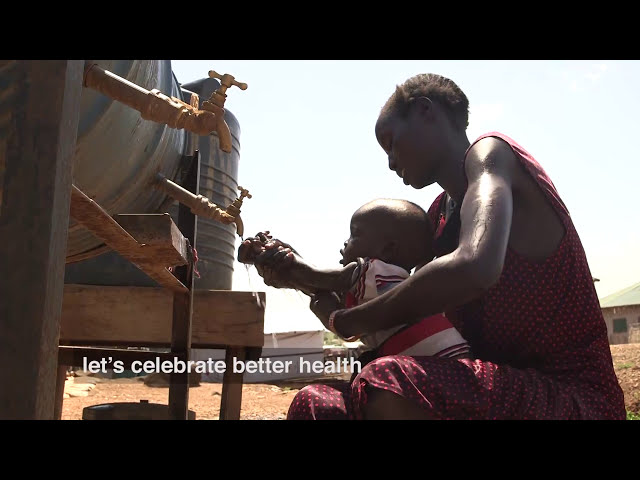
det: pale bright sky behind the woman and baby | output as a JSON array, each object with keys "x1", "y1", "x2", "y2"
[{"x1": 171, "y1": 60, "x2": 640, "y2": 333}]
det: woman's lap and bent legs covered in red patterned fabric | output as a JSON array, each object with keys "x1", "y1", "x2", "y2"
[{"x1": 287, "y1": 356, "x2": 592, "y2": 420}]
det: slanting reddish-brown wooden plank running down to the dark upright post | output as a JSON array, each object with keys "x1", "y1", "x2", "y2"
[{"x1": 70, "y1": 185, "x2": 187, "y2": 292}]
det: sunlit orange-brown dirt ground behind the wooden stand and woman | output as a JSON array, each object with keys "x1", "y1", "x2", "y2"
[{"x1": 62, "y1": 343, "x2": 640, "y2": 420}]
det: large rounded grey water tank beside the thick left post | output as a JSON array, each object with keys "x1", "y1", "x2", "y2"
[{"x1": 67, "y1": 60, "x2": 189, "y2": 262}]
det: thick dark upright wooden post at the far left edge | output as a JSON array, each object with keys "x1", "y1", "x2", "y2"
[{"x1": 0, "y1": 60, "x2": 84, "y2": 419}]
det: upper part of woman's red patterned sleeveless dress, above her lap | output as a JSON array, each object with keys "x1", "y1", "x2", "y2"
[{"x1": 429, "y1": 132, "x2": 626, "y2": 418}]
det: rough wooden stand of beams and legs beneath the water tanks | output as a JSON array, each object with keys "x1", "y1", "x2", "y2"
[{"x1": 56, "y1": 157, "x2": 264, "y2": 420}]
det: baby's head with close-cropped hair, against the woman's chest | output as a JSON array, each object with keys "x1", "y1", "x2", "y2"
[{"x1": 340, "y1": 198, "x2": 434, "y2": 271}]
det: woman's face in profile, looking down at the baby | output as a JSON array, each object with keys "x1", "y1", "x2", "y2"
[{"x1": 376, "y1": 104, "x2": 438, "y2": 189}]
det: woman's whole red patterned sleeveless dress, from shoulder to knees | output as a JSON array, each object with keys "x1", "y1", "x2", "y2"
[{"x1": 288, "y1": 132, "x2": 626, "y2": 420}]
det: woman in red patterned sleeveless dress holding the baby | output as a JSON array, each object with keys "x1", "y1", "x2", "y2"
[{"x1": 249, "y1": 74, "x2": 625, "y2": 419}]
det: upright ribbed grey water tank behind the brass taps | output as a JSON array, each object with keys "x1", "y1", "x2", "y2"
[{"x1": 178, "y1": 78, "x2": 240, "y2": 290}]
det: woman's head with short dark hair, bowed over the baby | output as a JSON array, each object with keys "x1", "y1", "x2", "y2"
[{"x1": 376, "y1": 73, "x2": 469, "y2": 188}]
